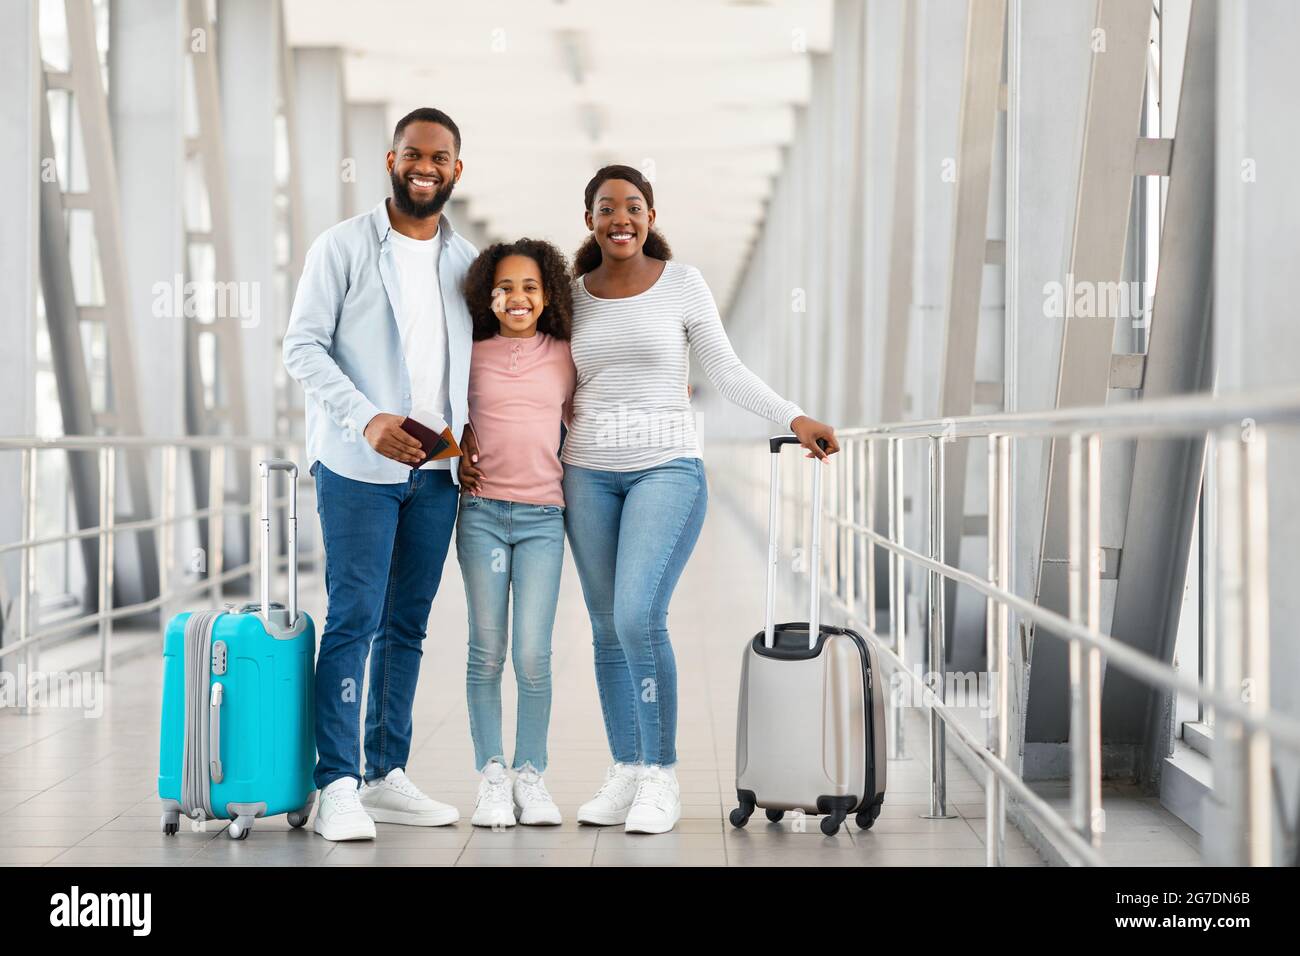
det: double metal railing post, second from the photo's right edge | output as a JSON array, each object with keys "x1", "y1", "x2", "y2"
[{"x1": 1069, "y1": 433, "x2": 1102, "y2": 847}]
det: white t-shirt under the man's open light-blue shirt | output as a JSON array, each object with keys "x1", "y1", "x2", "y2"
[{"x1": 389, "y1": 229, "x2": 451, "y2": 468}]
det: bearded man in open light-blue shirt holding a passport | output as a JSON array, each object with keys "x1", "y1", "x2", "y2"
[{"x1": 285, "y1": 108, "x2": 476, "y2": 840}]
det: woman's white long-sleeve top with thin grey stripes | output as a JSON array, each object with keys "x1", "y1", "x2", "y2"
[{"x1": 560, "y1": 261, "x2": 803, "y2": 471}]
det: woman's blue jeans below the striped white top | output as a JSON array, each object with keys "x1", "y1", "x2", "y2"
[{"x1": 564, "y1": 458, "x2": 709, "y2": 766}]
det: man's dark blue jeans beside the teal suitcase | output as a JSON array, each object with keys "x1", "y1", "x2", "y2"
[{"x1": 312, "y1": 462, "x2": 458, "y2": 790}]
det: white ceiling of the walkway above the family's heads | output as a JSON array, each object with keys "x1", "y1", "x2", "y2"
[{"x1": 285, "y1": 0, "x2": 831, "y2": 303}]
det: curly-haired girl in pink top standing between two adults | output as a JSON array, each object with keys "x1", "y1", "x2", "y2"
[{"x1": 456, "y1": 239, "x2": 575, "y2": 827}]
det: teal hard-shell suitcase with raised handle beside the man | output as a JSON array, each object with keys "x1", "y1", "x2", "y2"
[{"x1": 159, "y1": 459, "x2": 316, "y2": 840}]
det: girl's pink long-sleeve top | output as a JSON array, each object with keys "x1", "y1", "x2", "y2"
[{"x1": 469, "y1": 332, "x2": 577, "y2": 505}]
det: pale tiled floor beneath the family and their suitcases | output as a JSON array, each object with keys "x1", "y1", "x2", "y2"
[{"x1": 0, "y1": 478, "x2": 1196, "y2": 866}]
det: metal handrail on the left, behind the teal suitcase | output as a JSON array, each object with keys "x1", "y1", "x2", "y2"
[{"x1": 0, "y1": 436, "x2": 319, "y2": 711}]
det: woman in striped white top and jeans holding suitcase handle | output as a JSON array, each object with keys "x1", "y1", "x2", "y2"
[{"x1": 562, "y1": 165, "x2": 839, "y2": 834}]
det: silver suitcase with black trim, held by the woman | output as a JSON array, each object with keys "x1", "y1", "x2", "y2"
[{"x1": 731, "y1": 436, "x2": 885, "y2": 835}]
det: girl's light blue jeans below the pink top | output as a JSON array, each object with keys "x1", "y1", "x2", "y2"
[{"x1": 456, "y1": 494, "x2": 564, "y2": 773}]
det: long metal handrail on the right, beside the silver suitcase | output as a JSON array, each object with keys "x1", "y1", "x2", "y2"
[{"x1": 722, "y1": 389, "x2": 1300, "y2": 865}]
